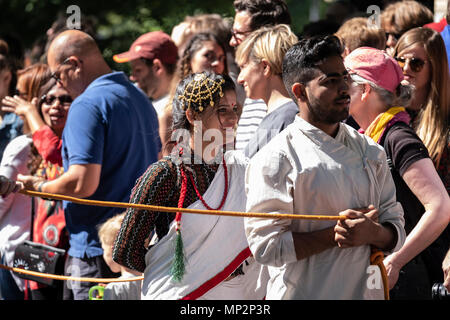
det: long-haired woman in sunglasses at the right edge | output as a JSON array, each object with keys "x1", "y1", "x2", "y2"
[{"x1": 394, "y1": 28, "x2": 450, "y2": 178}]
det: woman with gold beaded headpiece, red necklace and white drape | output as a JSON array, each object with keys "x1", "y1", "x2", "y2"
[{"x1": 113, "y1": 72, "x2": 264, "y2": 299}]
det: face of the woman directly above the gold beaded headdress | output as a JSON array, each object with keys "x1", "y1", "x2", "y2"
[{"x1": 191, "y1": 41, "x2": 225, "y2": 74}]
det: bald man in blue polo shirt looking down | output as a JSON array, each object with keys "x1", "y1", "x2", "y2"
[{"x1": 21, "y1": 30, "x2": 161, "y2": 300}]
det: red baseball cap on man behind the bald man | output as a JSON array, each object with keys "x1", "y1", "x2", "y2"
[{"x1": 113, "y1": 31, "x2": 178, "y2": 64}]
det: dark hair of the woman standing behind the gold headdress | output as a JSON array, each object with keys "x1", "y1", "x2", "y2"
[{"x1": 178, "y1": 32, "x2": 228, "y2": 79}]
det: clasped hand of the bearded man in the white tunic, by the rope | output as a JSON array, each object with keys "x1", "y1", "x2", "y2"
[{"x1": 334, "y1": 205, "x2": 378, "y2": 248}]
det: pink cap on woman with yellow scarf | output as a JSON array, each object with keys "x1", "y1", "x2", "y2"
[{"x1": 344, "y1": 47, "x2": 404, "y2": 92}]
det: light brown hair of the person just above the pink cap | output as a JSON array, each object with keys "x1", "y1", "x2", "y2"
[{"x1": 335, "y1": 17, "x2": 386, "y2": 52}]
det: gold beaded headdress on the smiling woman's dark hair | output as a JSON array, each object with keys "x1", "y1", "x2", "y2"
[{"x1": 178, "y1": 73, "x2": 225, "y2": 112}]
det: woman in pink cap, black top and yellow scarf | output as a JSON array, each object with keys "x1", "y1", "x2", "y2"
[{"x1": 345, "y1": 48, "x2": 450, "y2": 299}]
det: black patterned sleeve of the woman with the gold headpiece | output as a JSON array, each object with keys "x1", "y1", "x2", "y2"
[{"x1": 113, "y1": 159, "x2": 177, "y2": 272}]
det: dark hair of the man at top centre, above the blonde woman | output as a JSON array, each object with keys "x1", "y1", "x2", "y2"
[{"x1": 233, "y1": 0, "x2": 291, "y2": 31}]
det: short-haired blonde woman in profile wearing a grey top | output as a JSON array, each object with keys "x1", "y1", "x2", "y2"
[{"x1": 236, "y1": 24, "x2": 298, "y2": 157}]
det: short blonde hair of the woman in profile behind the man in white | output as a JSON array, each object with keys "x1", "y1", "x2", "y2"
[{"x1": 236, "y1": 24, "x2": 298, "y2": 76}]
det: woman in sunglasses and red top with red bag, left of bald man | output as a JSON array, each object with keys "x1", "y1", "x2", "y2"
[{"x1": 3, "y1": 64, "x2": 72, "y2": 300}]
